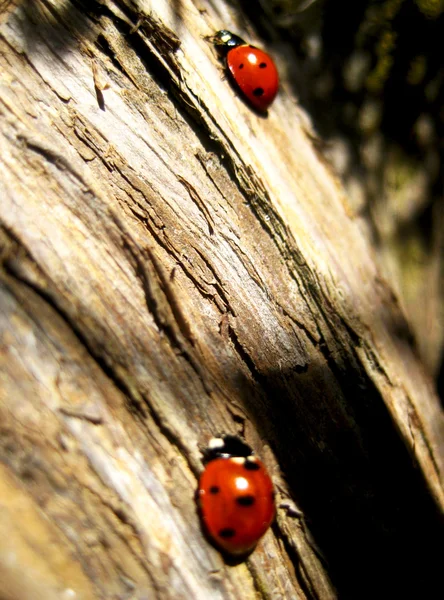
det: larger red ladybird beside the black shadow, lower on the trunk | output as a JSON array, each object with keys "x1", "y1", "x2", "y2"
[{"x1": 197, "y1": 436, "x2": 275, "y2": 556}]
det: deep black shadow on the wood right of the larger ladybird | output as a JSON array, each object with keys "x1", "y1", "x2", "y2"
[{"x1": 262, "y1": 354, "x2": 440, "y2": 599}]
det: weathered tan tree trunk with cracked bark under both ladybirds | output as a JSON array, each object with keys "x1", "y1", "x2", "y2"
[{"x1": 0, "y1": 0, "x2": 443, "y2": 600}]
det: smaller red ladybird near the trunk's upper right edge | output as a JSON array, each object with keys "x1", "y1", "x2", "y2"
[{"x1": 208, "y1": 29, "x2": 279, "y2": 113}]
